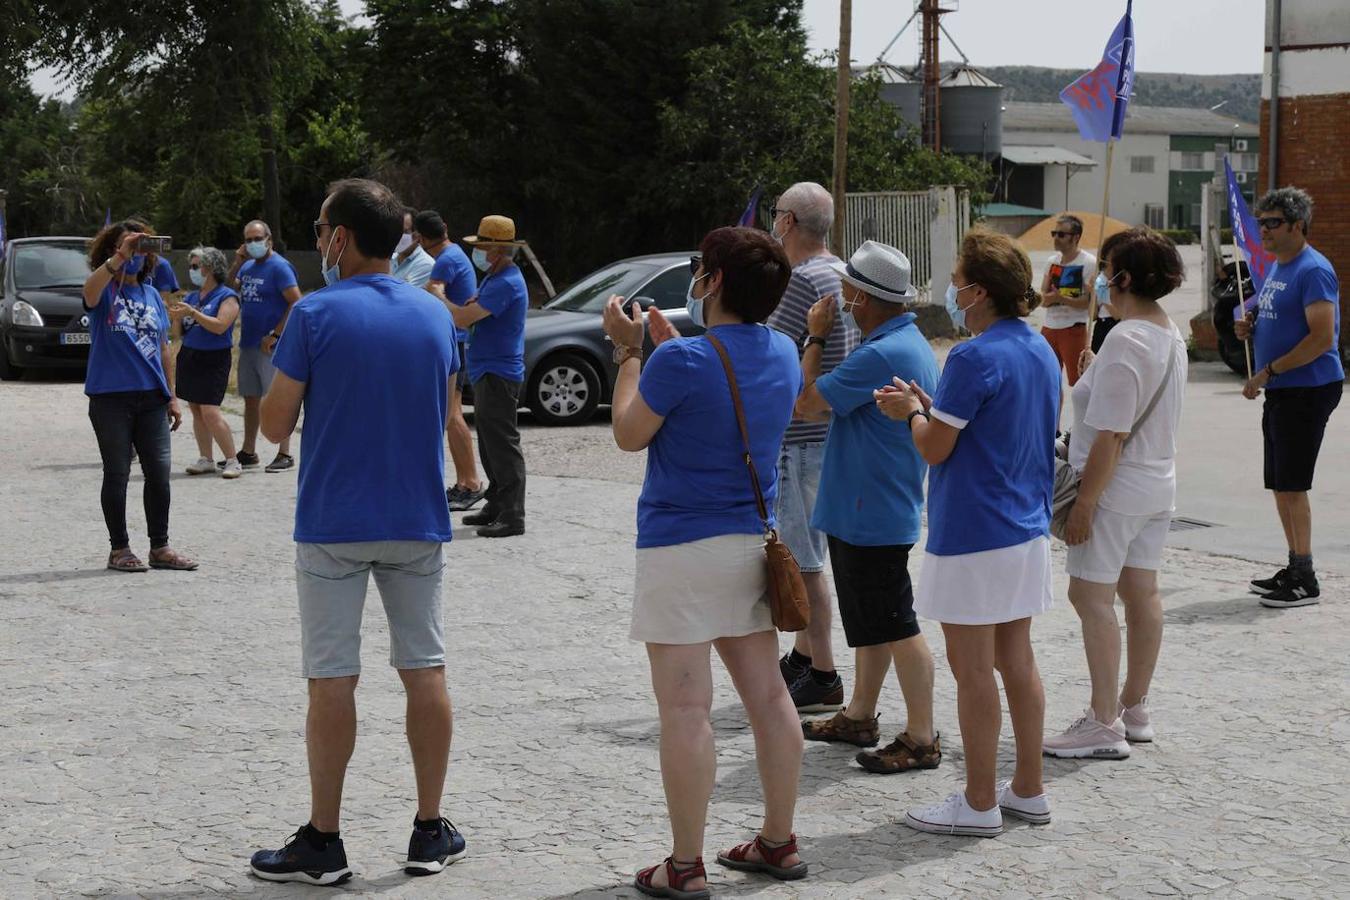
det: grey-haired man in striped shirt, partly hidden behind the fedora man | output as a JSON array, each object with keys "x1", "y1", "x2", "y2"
[{"x1": 765, "y1": 181, "x2": 860, "y2": 712}]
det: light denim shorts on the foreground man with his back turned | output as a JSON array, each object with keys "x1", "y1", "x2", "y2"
[{"x1": 296, "y1": 541, "x2": 446, "y2": 679}]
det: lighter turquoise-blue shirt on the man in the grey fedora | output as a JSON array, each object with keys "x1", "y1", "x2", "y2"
[{"x1": 811, "y1": 313, "x2": 937, "y2": 546}]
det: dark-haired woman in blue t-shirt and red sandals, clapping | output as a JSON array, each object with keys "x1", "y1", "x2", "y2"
[{"x1": 605, "y1": 228, "x2": 806, "y2": 897}]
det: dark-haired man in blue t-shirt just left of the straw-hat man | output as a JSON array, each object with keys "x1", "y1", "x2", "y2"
[{"x1": 413, "y1": 209, "x2": 486, "y2": 513}]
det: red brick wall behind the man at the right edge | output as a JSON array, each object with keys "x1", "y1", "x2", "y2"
[{"x1": 1257, "y1": 93, "x2": 1350, "y2": 347}]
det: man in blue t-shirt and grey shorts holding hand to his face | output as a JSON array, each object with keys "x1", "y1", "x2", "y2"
[{"x1": 228, "y1": 219, "x2": 300, "y2": 472}]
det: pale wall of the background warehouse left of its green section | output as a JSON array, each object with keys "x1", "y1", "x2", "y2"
[{"x1": 1003, "y1": 128, "x2": 1170, "y2": 225}]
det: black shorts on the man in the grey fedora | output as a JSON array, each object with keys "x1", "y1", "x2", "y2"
[{"x1": 829, "y1": 536, "x2": 919, "y2": 646}]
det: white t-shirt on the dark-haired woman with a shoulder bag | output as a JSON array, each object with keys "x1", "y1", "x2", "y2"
[{"x1": 1069, "y1": 318, "x2": 1187, "y2": 515}]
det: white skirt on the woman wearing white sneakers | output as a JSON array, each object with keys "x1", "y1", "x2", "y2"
[{"x1": 914, "y1": 537, "x2": 1054, "y2": 625}]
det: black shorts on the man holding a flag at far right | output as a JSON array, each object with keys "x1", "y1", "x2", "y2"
[{"x1": 1261, "y1": 382, "x2": 1343, "y2": 493}]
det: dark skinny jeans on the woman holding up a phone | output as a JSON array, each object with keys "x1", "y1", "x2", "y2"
[{"x1": 89, "y1": 391, "x2": 170, "y2": 551}]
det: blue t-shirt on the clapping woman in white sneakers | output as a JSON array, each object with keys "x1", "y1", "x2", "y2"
[{"x1": 927, "y1": 318, "x2": 1060, "y2": 556}]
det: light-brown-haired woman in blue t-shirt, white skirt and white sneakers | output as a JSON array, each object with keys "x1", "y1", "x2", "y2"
[{"x1": 878, "y1": 229, "x2": 1060, "y2": 837}]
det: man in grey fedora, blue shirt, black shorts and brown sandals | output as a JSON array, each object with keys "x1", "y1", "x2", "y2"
[{"x1": 797, "y1": 240, "x2": 942, "y2": 775}]
